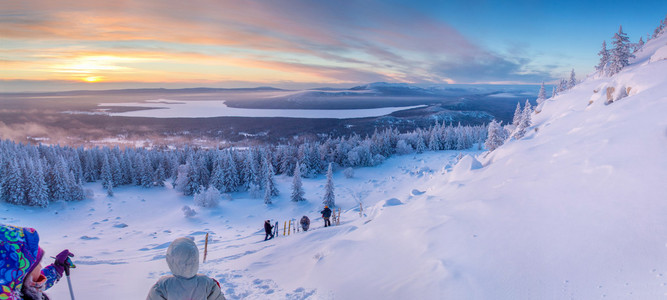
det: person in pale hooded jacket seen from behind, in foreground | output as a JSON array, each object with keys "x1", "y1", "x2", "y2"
[{"x1": 146, "y1": 237, "x2": 225, "y2": 300}]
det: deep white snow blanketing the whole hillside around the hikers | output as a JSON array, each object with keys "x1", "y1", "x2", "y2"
[{"x1": 0, "y1": 31, "x2": 667, "y2": 299}]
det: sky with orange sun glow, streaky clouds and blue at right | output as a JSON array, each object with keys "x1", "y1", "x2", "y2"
[{"x1": 0, "y1": 0, "x2": 667, "y2": 92}]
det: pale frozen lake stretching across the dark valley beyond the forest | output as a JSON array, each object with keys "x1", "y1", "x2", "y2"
[{"x1": 99, "y1": 99, "x2": 426, "y2": 119}]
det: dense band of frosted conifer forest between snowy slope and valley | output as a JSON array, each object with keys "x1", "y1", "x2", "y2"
[{"x1": 0, "y1": 123, "x2": 487, "y2": 207}]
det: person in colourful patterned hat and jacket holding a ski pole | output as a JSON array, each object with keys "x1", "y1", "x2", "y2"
[{"x1": 0, "y1": 224, "x2": 74, "y2": 300}]
